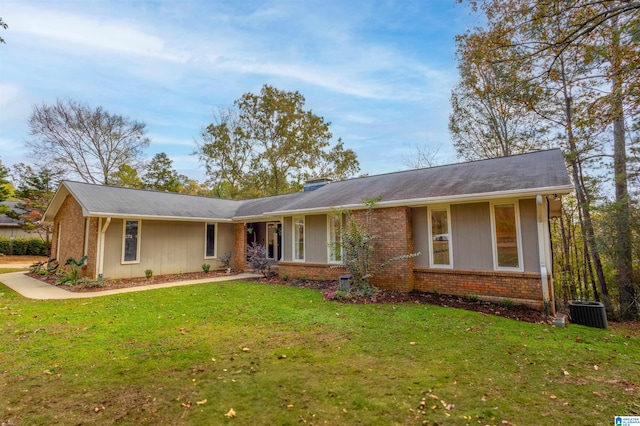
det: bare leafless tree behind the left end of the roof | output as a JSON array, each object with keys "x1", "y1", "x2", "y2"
[{"x1": 26, "y1": 99, "x2": 149, "y2": 184}]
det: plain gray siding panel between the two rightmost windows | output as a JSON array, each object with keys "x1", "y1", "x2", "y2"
[{"x1": 451, "y1": 203, "x2": 493, "y2": 271}]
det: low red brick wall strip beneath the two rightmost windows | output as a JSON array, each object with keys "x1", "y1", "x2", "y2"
[{"x1": 414, "y1": 268, "x2": 544, "y2": 309}]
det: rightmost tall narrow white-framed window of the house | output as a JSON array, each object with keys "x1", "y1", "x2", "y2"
[{"x1": 492, "y1": 203, "x2": 522, "y2": 269}]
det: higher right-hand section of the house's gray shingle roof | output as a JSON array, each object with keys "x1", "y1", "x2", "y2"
[{"x1": 262, "y1": 149, "x2": 571, "y2": 212}]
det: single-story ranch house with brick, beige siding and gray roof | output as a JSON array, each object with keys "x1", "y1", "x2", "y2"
[{"x1": 43, "y1": 149, "x2": 573, "y2": 308}]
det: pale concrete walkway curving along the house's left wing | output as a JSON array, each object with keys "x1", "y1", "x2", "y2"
[{"x1": 0, "y1": 272, "x2": 262, "y2": 300}]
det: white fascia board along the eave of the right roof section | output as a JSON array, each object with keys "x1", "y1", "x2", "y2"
[{"x1": 265, "y1": 185, "x2": 574, "y2": 216}]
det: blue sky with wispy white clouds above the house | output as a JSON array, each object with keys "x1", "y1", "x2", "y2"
[{"x1": 0, "y1": 0, "x2": 480, "y2": 180}]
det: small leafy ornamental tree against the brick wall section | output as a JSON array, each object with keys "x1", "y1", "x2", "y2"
[{"x1": 330, "y1": 196, "x2": 420, "y2": 296}]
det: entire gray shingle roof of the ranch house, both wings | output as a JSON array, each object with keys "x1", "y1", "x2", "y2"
[{"x1": 45, "y1": 149, "x2": 572, "y2": 220}]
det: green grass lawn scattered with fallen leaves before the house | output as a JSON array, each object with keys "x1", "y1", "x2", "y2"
[{"x1": 0, "y1": 277, "x2": 640, "y2": 425}]
